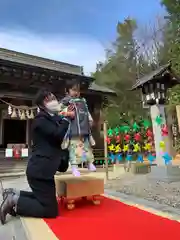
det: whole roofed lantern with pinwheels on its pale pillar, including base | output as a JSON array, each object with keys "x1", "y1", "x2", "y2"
[{"x1": 132, "y1": 64, "x2": 180, "y2": 181}]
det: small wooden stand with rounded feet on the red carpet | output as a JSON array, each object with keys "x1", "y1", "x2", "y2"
[{"x1": 55, "y1": 177, "x2": 104, "y2": 210}]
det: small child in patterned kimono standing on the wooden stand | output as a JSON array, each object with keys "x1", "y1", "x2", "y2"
[{"x1": 60, "y1": 80, "x2": 96, "y2": 177}]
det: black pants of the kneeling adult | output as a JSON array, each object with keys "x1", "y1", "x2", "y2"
[{"x1": 17, "y1": 178, "x2": 58, "y2": 218}]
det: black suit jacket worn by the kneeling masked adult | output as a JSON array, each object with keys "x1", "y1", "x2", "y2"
[{"x1": 26, "y1": 111, "x2": 69, "y2": 179}]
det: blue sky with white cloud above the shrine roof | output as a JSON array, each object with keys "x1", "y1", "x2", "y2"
[{"x1": 0, "y1": 0, "x2": 163, "y2": 72}]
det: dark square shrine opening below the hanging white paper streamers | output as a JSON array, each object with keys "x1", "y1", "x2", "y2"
[{"x1": 3, "y1": 119, "x2": 26, "y2": 148}]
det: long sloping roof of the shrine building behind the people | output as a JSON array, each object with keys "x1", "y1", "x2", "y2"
[{"x1": 0, "y1": 48, "x2": 116, "y2": 95}]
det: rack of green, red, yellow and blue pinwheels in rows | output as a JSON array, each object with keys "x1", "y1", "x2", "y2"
[{"x1": 104, "y1": 113, "x2": 156, "y2": 176}]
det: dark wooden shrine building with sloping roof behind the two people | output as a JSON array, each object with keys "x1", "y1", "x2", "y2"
[{"x1": 0, "y1": 48, "x2": 115, "y2": 167}]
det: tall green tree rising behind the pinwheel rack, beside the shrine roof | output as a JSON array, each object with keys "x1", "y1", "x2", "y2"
[{"x1": 94, "y1": 18, "x2": 147, "y2": 125}]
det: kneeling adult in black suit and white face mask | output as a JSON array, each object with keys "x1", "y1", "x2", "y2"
[{"x1": 0, "y1": 90, "x2": 74, "y2": 224}]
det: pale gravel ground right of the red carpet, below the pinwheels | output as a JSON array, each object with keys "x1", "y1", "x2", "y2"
[{"x1": 105, "y1": 174, "x2": 180, "y2": 208}]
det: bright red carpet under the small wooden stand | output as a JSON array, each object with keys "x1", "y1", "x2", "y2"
[{"x1": 45, "y1": 198, "x2": 180, "y2": 240}]
